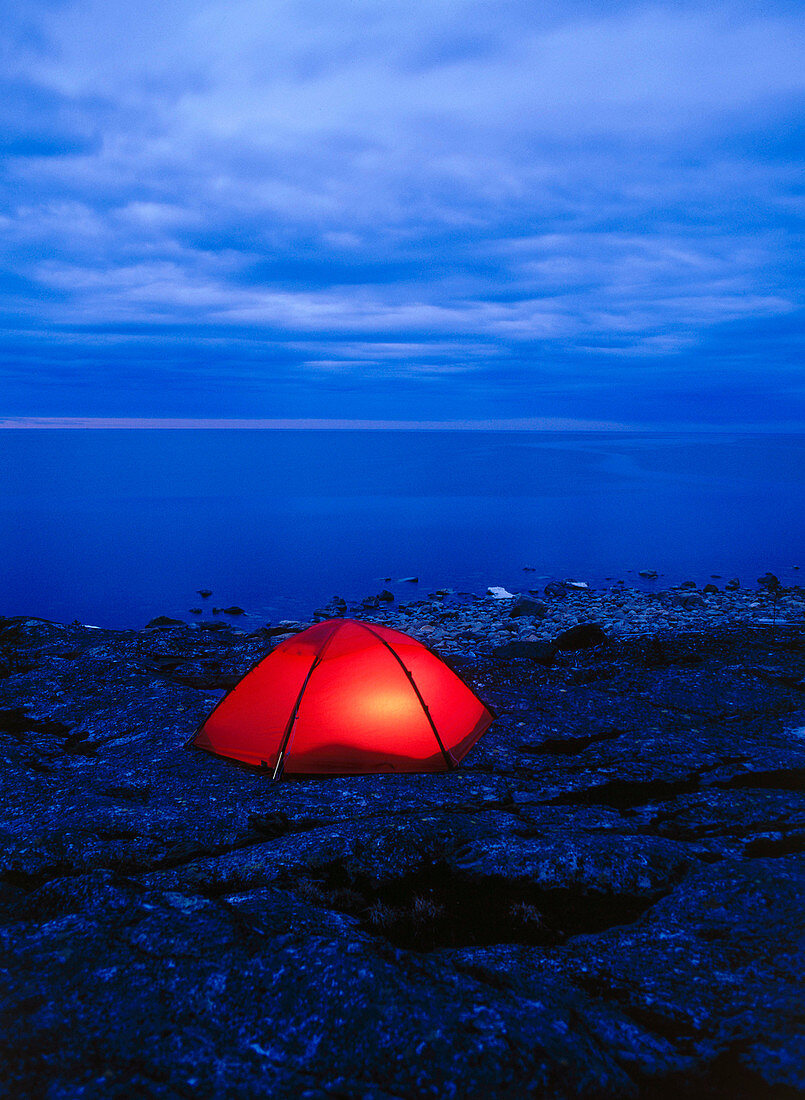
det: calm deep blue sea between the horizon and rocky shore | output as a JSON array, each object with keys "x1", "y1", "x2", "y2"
[{"x1": 0, "y1": 430, "x2": 805, "y2": 626}]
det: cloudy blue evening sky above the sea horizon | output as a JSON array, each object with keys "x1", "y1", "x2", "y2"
[{"x1": 0, "y1": 0, "x2": 805, "y2": 426}]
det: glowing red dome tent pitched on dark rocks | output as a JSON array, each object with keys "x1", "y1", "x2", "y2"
[{"x1": 191, "y1": 619, "x2": 495, "y2": 779}]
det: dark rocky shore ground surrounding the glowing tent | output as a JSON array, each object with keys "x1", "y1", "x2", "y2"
[{"x1": 0, "y1": 594, "x2": 805, "y2": 1100}]
